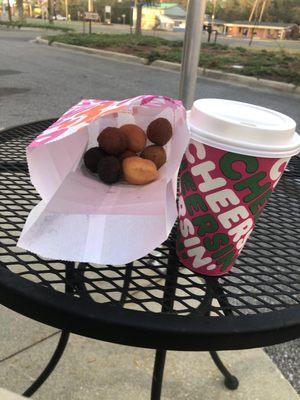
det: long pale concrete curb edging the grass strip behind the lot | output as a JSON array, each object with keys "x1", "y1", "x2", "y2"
[{"x1": 33, "y1": 36, "x2": 300, "y2": 94}]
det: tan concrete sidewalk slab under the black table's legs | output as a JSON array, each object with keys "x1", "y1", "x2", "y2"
[{"x1": 0, "y1": 307, "x2": 299, "y2": 400}]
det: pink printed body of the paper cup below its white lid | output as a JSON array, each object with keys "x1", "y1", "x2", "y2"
[{"x1": 177, "y1": 143, "x2": 289, "y2": 275}]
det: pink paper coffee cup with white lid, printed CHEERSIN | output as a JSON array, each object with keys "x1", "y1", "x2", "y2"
[{"x1": 177, "y1": 99, "x2": 300, "y2": 275}]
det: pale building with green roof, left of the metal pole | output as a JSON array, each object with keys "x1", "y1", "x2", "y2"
[{"x1": 133, "y1": 3, "x2": 186, "y2": 30}]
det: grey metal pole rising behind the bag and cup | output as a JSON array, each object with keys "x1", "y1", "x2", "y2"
[{"x1": 179, "y1": 0, "x2": 206, "y2": 109}]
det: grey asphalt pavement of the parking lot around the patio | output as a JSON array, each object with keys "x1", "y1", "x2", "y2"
[{"x1": 0, "y1": 29, "x2": 300, "y2": 392}]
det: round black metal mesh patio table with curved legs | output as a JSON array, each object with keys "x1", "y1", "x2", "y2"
[{"x1": 0, "y1": 120, "x2": 300, "y2": 400}]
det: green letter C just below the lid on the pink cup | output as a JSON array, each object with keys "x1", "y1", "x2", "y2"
[{"x1": 219, "y1": 153, "x2": 258, "y2": 180}]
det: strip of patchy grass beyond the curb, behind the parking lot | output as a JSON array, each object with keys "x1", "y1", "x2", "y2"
[{"x1": 47, "y1": 33, "x2": 300, "y2": 86}]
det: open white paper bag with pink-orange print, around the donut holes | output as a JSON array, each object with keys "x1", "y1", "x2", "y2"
[{"x1": 18, "y1": 96, "x2": 189, "y2": 264}]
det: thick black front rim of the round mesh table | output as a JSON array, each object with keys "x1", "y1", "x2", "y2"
[{"x1": 0, "y1": 266, "x2": 300, "y2": 351}]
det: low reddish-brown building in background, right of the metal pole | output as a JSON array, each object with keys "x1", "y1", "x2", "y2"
[{"x1": 223, "y1": 21, "x2": 299, "y2": 39}]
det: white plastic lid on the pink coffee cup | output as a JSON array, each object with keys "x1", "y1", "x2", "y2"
[{"x1": 187, "y1": 99, "x2": 300, "y2": 158}]
